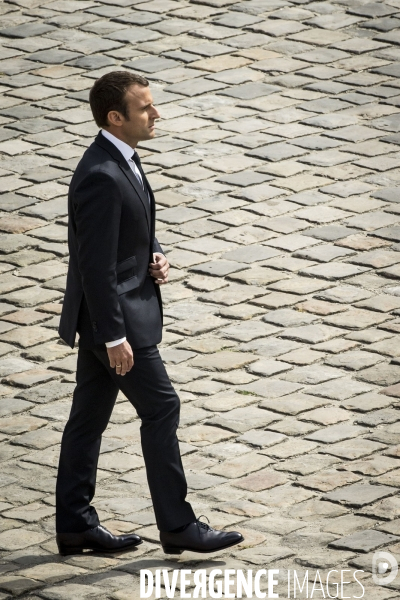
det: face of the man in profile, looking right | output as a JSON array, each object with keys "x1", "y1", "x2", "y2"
[{"x1": 106, "y1": 84, "x2": 160, "y2": 148}]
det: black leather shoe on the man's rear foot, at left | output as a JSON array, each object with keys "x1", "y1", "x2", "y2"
[{"x1": 56, "y1": 525, "x2": 143, "y2": 556}]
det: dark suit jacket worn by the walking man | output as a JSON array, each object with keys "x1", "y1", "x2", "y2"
[{"x1": 58, "y1": 132, "x2": 162, "y2": 348}]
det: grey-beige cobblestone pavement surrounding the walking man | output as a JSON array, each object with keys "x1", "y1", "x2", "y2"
[{"x1": 0, "y1": 0, "x2": 400, "y2": 600}]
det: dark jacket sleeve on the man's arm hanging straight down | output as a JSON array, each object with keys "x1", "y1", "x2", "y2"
[{"x1": 73, "y1": 171, "x2": 126, "y2": 344}]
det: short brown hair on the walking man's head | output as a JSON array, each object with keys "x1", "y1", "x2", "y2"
[{"x1": 89, "y1": 71, "x2": 149, "y2": 127}]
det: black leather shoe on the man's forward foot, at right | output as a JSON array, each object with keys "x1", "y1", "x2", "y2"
[{"x1": 160, "y1": 519, "x2": 244, "y2": 554}]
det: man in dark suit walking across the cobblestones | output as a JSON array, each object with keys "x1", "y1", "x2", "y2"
[{"x1": 56, "y1": 71, "x2": 243, "y2": 554}]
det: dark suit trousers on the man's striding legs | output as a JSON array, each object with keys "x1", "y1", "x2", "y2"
[{"x1": 56, "y1": 344, "x2": 196, "y2": 533}]
